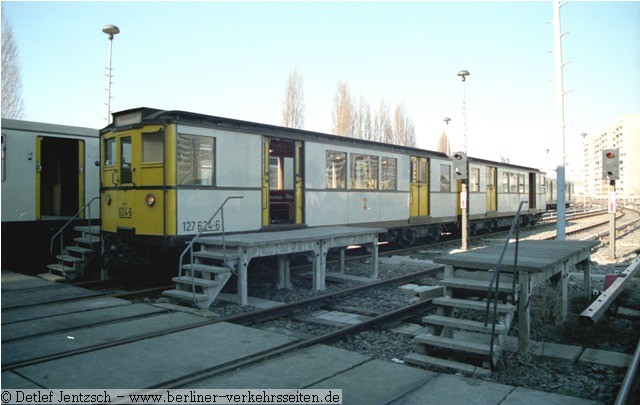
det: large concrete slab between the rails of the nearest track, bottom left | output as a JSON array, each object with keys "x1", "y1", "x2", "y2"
[{"x1": 11, "y1": 322, "x2": 295, "y2": 389}]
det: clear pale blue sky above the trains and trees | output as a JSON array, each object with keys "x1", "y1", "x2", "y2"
[{"x1": 2, "y1": 1, "x2": 640, "y2": 175}]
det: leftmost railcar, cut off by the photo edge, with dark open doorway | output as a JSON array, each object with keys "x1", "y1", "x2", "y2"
[{"x1": 2, "y1": 118, "x2": 100, "y2": 272}]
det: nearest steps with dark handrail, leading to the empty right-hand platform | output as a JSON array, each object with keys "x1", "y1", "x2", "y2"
[{"x1": 404, "y1": 202, "x2": 524, "y2": 375}]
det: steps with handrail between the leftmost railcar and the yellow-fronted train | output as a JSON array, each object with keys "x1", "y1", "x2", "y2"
[{"x1": 38, "y1": 197, "x2": 102, "y2": 281}]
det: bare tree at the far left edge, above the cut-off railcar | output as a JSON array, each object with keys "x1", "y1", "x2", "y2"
[{"x1": 2, "y1": 10, "x2": 24, "y2": 119}]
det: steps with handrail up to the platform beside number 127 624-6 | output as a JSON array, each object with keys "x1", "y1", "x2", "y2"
[{"x1": 162, "y1": 197, "x2": 242, "y2": 309}]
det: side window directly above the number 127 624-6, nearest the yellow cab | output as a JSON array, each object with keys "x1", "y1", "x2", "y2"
[{"x1": 176, "y1": 134, "x2": 215, "y2": 186}]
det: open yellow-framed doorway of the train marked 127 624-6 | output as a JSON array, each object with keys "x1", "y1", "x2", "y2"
[{"x1": 262, "y1": 138, "x2": 304, "y2": 226}]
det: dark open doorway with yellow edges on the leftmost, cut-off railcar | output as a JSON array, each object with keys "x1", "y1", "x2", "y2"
[{"x1": 35, "y1": 136, "x2": 85, "y2": 219}]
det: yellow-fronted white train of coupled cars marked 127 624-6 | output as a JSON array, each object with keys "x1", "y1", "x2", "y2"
[{"x1": 101, "y1": 108, "x2": 544, "y2": 272}]
